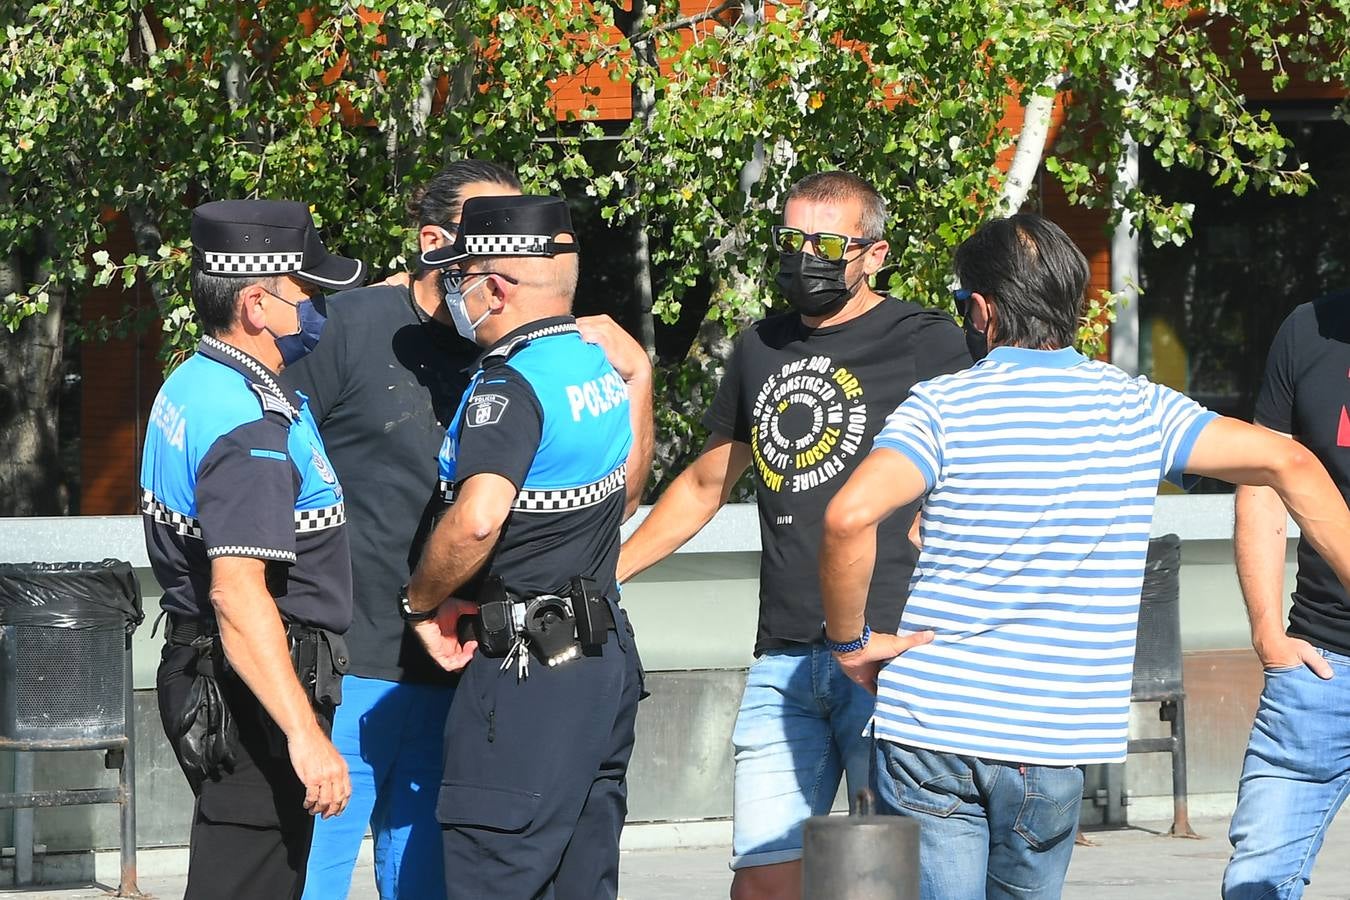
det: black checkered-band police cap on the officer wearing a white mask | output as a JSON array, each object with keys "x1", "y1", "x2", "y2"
[{"x1": 421, "y1": 194, "x2": 576, "y2": 269}]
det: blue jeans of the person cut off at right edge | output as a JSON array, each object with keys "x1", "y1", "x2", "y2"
[{"x1": 1223, "y1": 650, "x2": 1350, "y2": 900}]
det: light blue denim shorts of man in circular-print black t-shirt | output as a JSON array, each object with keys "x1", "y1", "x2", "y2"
[{"x1": 732, "y1": 644, "x2": 873, "y2": 869}]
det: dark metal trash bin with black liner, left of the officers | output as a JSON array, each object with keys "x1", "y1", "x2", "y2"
[{"x1": 0, "y1": 560, "x2": 144, "y2": 896}]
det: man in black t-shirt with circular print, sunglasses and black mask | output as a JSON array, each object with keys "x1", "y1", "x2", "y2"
[{"x1": 618, "y1": 171, "x2": 971, "y2": 900}]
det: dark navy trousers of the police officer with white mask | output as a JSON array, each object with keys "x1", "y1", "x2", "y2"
[{"x1": 436, "y1": 606, "x2": 643, "y2": 900}]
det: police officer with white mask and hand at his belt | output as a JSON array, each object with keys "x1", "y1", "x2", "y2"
[{"x1": 400, "y1": 197, "x2": 645, "y2": 900}]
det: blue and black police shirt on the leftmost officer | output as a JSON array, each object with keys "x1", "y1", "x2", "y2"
[{"x1": 140, "y1": 337, "x2": 351, "y2": 633}]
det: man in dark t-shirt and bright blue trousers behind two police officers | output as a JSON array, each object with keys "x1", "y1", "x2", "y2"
[{"x1": 284, "y1": 159, "x2": 651, "y2": 900}]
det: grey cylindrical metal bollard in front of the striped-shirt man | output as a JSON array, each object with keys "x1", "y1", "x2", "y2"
[{"x1": 802, "y1": 797, "x2": 919, "y2": 900}]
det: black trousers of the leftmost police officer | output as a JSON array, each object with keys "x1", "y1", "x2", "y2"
[{"x1": 155, "y1": 644, "x2": 315, "y2": 900}]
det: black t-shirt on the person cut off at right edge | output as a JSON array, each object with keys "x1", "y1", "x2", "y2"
[{"x1": 1256, "y1": 291, "x2": 1350, "y2": 653}]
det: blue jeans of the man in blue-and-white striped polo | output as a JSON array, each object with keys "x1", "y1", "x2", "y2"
[{"x1": 872, "y1": 741, "x2": 1083, "y2": 900}]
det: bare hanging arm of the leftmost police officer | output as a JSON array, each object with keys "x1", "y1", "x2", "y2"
[{"x1": 211, "y1": 556, "x2": 351, "y2": 819}]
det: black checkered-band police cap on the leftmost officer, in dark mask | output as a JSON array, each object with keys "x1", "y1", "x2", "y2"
[{"x1": 192, "y1": 200, "x2": 367, "y2": 290}]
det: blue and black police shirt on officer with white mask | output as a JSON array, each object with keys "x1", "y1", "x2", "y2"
[{"x1": 440, "y1": 316, "x2": 633, "y2": 598}]
